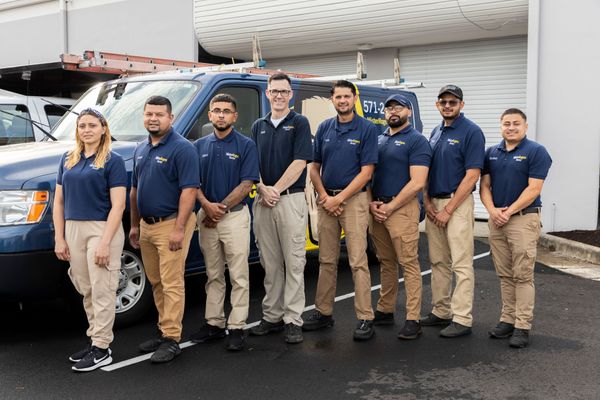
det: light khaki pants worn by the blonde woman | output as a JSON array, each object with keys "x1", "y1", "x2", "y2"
[{"x1": 65, "y1": 220, "x2": 125, "y2": 349}]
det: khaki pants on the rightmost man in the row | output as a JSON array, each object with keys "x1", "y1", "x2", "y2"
[{"x1": 488, "y1": 214, "x2": 540, "y2": 329}]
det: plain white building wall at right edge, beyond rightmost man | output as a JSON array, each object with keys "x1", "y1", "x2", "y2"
[{"x1": 528, "y1": 0, "x2": 600, "y2": 231}]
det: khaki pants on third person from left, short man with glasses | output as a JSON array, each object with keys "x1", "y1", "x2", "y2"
[{"x1": 198, "y1": 207, "x2": 250, "y2": 329}]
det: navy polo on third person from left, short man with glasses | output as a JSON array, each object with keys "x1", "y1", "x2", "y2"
[{"x1": 194, "y1": 129, "x2": 259, "y2": 203}]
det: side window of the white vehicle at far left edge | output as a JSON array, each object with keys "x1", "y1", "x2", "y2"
[{"x1": 0, "y1": 104, "x2": 35, "y2": 145}]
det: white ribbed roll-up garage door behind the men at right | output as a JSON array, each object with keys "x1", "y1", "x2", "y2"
[{"x1": 269, "y1": 36, "x2": 527, "y2": 219}]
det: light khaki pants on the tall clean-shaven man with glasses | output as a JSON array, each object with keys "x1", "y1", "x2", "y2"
[{"x1": 252, "y1": 192, "x2": 307, "y2": 326}]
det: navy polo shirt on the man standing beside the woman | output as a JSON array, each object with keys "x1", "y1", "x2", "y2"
[{"x1": 131, "y1": 129, "x2": 200, "y2": 217}]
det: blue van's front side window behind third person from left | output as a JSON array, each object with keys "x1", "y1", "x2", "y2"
[{"x1": 187, "y1": 87, "x2": 260, "y2": 142}]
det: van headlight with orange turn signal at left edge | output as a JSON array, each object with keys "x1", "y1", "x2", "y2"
[{"x1": 0, "y1": 190, "x2": 50, "y2": 226}]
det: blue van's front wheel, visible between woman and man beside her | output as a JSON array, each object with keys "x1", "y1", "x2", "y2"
[{"x1": 115, "y1": 248, "x2": 153, "y2": 327}]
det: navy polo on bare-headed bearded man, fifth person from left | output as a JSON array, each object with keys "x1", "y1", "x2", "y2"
[{"x1": 313, "y1": 114, "x2": 381, "y2": 190}]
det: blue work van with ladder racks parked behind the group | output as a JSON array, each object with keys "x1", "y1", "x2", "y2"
[{"x1": 0, "y1": 70, "x2": 422, "y2": 325}]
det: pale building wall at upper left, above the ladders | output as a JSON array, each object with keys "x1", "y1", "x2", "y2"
[{"x1": 0, "y1": 0, "x2": 198, "y2": 68}]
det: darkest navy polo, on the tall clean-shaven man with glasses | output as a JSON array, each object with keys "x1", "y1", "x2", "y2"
[{"x1": 252, "y1": 111, "x2": 312, "y2": 189}]
